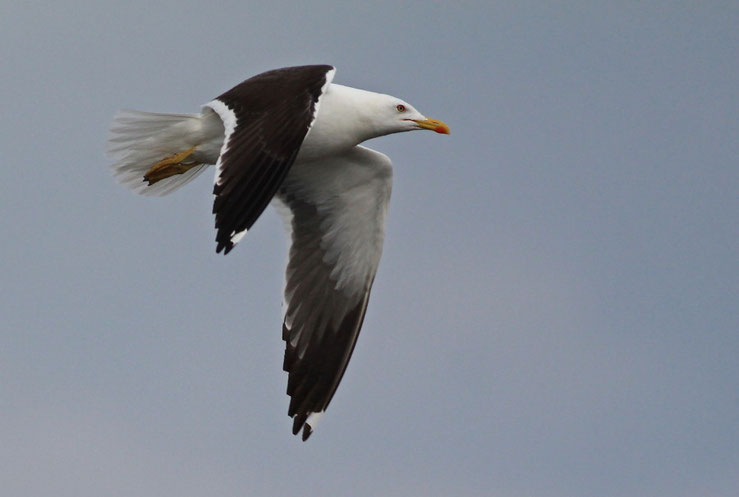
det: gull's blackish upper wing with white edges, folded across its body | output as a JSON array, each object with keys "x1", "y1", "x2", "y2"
[{"x1": 206, "y1": 66, "x2": 334, "y2": 254}]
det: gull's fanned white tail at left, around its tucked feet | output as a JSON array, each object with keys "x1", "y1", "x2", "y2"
[{"x1": 107, "y1": 110, "x2": 209, "y2": 195}]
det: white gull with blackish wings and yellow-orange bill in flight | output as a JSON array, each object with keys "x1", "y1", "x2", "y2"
[{"x1": 107, "y1": 65, "x2": 450, "y2": 441}]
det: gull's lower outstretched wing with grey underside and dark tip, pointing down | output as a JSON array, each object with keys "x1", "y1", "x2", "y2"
[{"x1": 277, "y1": 147, "x2": 392, "y2": 440}]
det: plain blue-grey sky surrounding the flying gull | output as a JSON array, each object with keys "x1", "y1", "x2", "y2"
[{"x1": 0, "y1": 1, "x2": 739, "y2": 497}]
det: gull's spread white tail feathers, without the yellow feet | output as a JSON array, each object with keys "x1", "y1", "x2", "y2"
[{"x1": 107, "y1": 110, "x2": 223, "y2": 195}]
